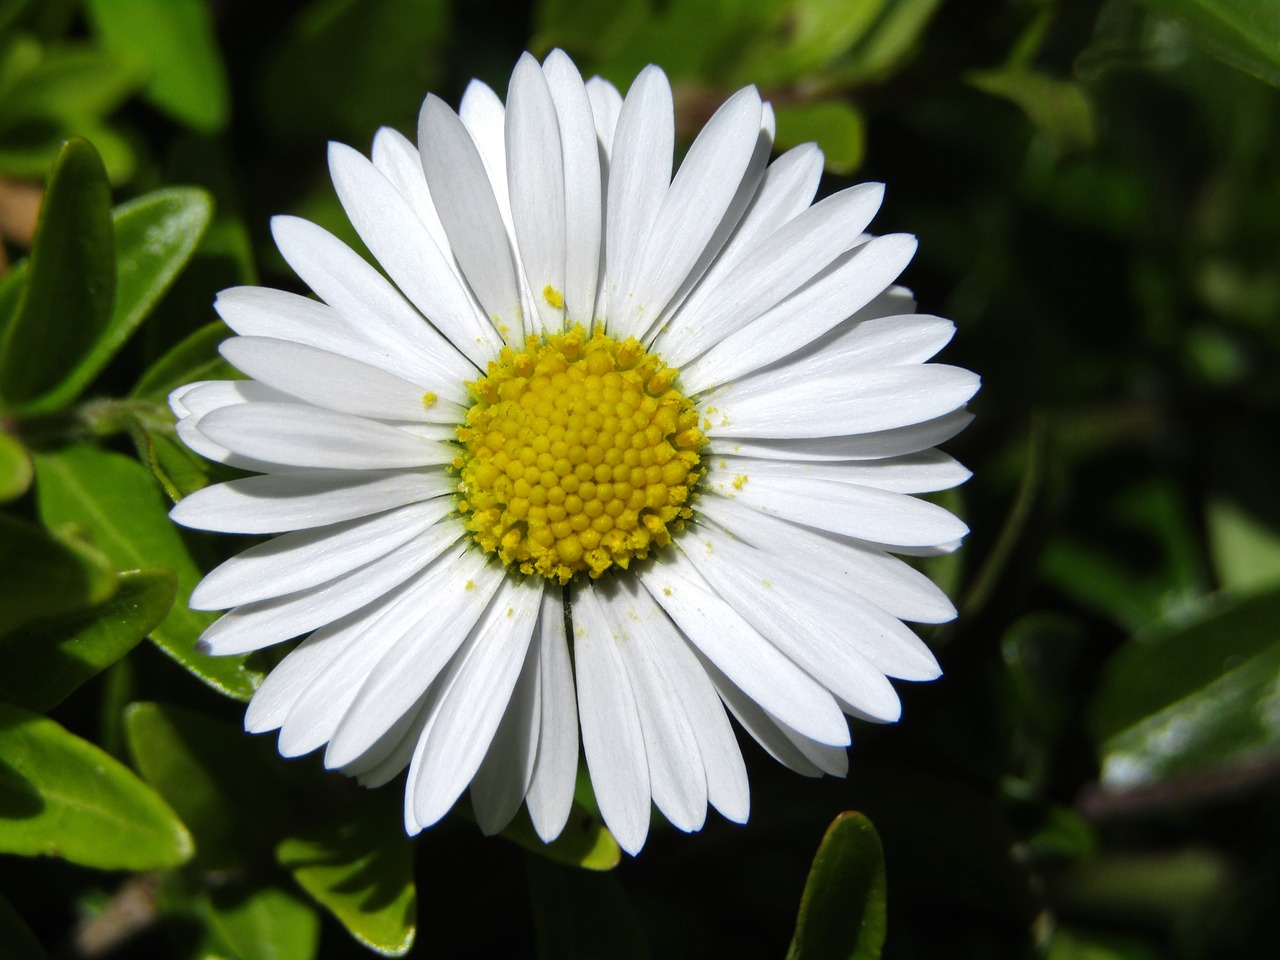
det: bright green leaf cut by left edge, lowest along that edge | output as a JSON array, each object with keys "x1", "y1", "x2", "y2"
[{"x1": 0, "y1": 704, "x2": 192, "y2": 870}]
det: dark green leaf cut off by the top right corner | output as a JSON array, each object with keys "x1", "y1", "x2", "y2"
[{"x1": 1139, "y1": 0, "x2": 1280, "y2": 87}]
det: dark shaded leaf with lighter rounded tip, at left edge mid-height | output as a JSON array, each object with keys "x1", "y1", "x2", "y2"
[{"x1": 0, "y1": 513, "x2": 118, "y2": 637}]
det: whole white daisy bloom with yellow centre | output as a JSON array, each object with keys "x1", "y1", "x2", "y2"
[{"x1": 173, "y1": 51, "x2": 978, "y2": 852}]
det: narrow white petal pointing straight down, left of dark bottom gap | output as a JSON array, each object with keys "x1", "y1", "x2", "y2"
[{"x1": 527, "y1": 590, "x2": 577, "y2": 844}]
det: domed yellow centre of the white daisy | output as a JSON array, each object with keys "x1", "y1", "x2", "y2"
[{"x1": 454, "y1": 326, "x2": 707, "y2": 584}]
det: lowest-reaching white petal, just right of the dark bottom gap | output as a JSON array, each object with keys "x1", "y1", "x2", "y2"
[{"x1": 571, "y1": 585, "x2": 649, "y2": 855}]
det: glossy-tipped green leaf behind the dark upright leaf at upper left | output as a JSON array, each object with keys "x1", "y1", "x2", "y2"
[{"x1": 32, "y1": 187, "x2": 212, "y2": 410}]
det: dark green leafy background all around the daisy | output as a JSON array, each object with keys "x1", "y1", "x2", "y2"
[{"x1": 0, "y1": 0, "x2": 1280, "y2": 960}]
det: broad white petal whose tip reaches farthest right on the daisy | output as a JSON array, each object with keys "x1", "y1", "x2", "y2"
[{"x1": 707, "y1": 364, "x2": 979, "y2": 438}]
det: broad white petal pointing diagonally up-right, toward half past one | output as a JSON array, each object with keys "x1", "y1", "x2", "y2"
[{"x1": 654, "y1": 183, "x2": 884, "y2": 366}]
